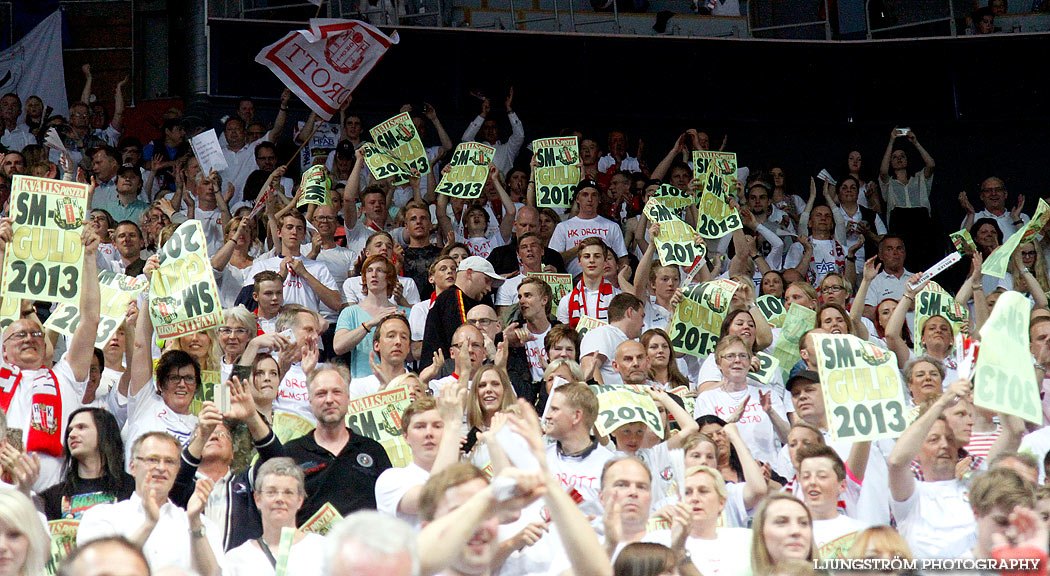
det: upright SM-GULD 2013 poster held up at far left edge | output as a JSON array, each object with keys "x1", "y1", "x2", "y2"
[{"x1": 0, "y1": 174, "x2": 87, "y2": 305}]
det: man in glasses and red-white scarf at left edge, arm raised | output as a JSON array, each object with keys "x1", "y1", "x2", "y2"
[{"x1": 0, "y1": 224, "x2": 100, "y2": 492}]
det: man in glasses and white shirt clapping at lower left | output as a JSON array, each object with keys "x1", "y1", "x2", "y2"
[{"x1": 77, "y1": 432, "x2": 223, "y2": 576}]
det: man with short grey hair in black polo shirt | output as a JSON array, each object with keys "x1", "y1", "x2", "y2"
[{"x1": 285, "y1": 364, "x2": 391, "y2": 526}]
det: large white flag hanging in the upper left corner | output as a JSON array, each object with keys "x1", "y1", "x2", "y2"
[{"x1": 0, "y1": 10, "x2": 69, "y2": 115}]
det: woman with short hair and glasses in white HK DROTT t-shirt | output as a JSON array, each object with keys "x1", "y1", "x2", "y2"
[{"x1": 693, "y1": 335, "x2": 791, "y2": 463}]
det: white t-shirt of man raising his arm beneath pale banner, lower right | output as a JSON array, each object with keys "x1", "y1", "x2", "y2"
[{"x1": 889, "y1": 479, "x2": 978, "y2": 558}]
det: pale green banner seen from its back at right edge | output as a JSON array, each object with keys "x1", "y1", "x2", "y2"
[{"x1": 974, "y1": 291, "x2": 1043, "y2": 425}]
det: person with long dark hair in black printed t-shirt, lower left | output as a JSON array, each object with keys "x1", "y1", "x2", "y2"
[{"x1": 40, "y1": 408, "x2": 134, "y2": 520}]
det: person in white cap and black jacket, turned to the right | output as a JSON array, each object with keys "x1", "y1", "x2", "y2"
[{"x1": 419, "y1": 256, "x2": 503, "y2": 369}]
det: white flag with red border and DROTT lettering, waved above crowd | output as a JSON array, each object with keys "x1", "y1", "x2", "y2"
[{"x1": 255, "y1": 18, "x2": 399, "y2": 120}]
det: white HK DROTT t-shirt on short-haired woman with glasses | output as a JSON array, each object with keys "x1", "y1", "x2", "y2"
[{"x1": 693, "y1": 384, "x2": 788, "y2": 463}]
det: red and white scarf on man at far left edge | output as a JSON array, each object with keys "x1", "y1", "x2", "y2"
[{"x1": 0, "y1": 365, "x2": 62, "y2": 457}]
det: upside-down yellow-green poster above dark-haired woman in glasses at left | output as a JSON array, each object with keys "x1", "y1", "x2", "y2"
[{"x1": 149, "y1": 220, "x2": 223, "y2": 339}]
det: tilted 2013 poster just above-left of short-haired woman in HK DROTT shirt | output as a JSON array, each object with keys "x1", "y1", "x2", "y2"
[{"x1": 669, "y1": 280, "x2": 739, "y2": 358}]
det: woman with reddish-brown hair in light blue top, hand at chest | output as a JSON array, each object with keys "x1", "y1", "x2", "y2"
[{"x1": 333, "y1": 255, "x2": 408, "y2": 378}]
